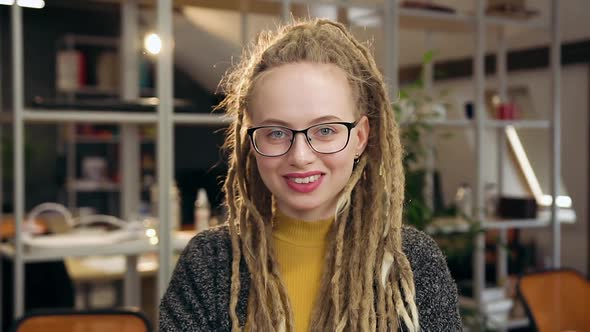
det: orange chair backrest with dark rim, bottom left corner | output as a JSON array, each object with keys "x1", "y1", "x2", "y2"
[{"x1": 11, "y1": 309, "x2": 152, "y2": 332}]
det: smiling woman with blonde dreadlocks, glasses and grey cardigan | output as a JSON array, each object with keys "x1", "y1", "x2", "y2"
[{"x1": 160, "y1": 20, "x2": 461, "y2": 331}]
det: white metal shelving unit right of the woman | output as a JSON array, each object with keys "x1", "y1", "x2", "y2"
[{"x1": 383, "y1": 0, "x2": 561, "y2": 330}]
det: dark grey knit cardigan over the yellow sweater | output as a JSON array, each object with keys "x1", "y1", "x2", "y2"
[{"x1": 160, "y1": 226, "x2": 462, "y2": 332}]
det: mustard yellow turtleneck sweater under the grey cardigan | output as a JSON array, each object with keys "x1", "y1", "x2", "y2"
[{"x1": 272, "y1": 211, "x2": 334, "y2": 331}]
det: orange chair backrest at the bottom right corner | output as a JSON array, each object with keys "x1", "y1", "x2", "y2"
[{"x1": 517, "y1": 269, "x2": 590, "y2": 332}]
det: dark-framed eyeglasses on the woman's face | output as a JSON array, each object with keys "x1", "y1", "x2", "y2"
[{"x1": 247, "y1": 121, "x2": 358, "y2": 157}]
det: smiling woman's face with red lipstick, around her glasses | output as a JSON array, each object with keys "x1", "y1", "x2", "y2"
[{"x1": 248, "y1": 62, "x2": 369, "y2": 221}]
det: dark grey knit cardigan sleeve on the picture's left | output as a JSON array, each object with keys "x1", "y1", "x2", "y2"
[{"x1": 159, "y1": 227, "x2": 249, "y2": 332}]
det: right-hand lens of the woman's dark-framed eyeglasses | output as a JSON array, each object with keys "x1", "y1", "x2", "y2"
[{"x1": 307, "y1": 123, "x2": 349, "y2": 153}]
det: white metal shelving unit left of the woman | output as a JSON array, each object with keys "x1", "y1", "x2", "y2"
[{"x1": 0, "y1": 0, "x2": 231, "y2": 326}]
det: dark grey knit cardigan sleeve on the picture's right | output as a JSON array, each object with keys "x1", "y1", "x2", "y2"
[{"x1": 402, "y1": 227, "x2": 462, "y2": 332}]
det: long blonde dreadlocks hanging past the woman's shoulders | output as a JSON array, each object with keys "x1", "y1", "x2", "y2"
[{"x1": 220, "y1": 20, "x2": 419, "y2": 331}]
